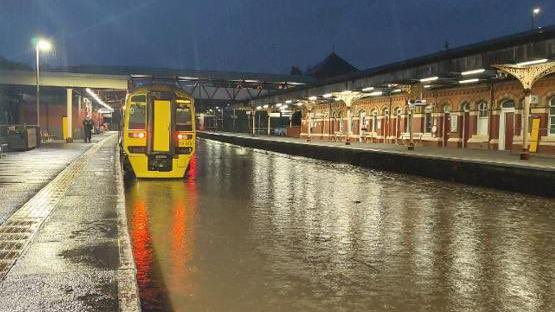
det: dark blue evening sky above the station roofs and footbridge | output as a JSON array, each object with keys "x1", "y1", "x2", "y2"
[{"x1": 0, "y1": 0, "x2": 555, "y2": 73}]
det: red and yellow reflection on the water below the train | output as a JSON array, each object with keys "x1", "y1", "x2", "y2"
[{"x1": 127, "y1": 163, "x2": 198, "y2": 310}]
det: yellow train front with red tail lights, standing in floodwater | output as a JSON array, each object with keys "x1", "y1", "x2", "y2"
[{"x1": 121, "y1": 85, "x2": 196, "y2": 178}]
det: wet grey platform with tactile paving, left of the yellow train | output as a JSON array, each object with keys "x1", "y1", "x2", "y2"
[{"x1": 0, "y1": 133, "x2": 140, "y2": 311}]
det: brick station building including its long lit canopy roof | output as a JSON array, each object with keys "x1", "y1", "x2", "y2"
[{"x1": 251, "y1": 26, "x2": 555, "y2": 154}]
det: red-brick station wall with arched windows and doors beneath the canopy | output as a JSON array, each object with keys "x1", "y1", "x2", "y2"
[{"x1": 301, "y1": 76, "x2": 555, "y2": 154}]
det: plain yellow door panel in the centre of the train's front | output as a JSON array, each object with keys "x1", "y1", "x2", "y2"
[{"x1": 153, "y1": 100, "x2": 171, "y2": 152}]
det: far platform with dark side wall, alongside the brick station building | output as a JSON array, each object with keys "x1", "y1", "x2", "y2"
[{"x1": 198, "y1": 131, "x2": 555, "y2": 197}]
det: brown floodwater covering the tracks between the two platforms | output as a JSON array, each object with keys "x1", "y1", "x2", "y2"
[{"x1": 126, "y1": 140, "x2": 555, "y2": 311}]
